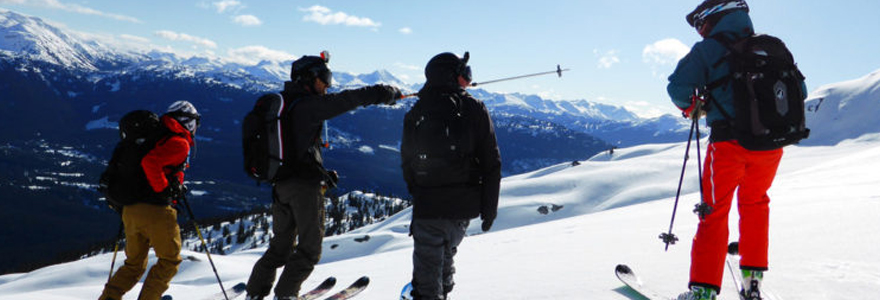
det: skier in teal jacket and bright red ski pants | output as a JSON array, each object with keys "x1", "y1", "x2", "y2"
[{"x1": 667, "y1": 0, "x2": 782, "y2": 299}]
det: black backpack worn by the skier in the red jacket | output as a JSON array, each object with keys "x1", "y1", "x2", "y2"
[{"x1": 98, "y1": 110, "x2": 173, "y2": 211}]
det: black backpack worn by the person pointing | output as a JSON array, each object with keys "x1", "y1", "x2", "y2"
[{"x1": 241, "y1": 94, "x2": 298, "y2": 183}]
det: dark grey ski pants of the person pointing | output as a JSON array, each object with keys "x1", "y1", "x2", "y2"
[{"x1": 247, "y1": 180, "x2": 324, "y2": 297}]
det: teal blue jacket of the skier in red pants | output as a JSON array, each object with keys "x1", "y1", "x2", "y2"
[{"x1": 666, "y1": 11, "x2": 755, "y2": 124}]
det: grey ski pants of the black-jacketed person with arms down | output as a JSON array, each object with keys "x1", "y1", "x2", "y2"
[{"x1": 410, "y1": 219, "x2": 470, "y2": 299}]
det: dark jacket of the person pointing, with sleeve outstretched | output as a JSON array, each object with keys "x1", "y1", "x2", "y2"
[{"x1": 276, "y1": 81, "x2": 391, "y2": 183}]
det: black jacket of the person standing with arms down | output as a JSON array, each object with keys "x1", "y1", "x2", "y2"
[{"x1": 400, "y1": 86, "x2": 501, "y2": 219}]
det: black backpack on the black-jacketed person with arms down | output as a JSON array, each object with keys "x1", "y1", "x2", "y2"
[{"x1": 409, "y1": 96, "x2": 479, "y2": 187}]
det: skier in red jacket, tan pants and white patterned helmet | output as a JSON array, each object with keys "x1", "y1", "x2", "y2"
[{"x1": 98, "y1": 101, "x2": 201, "y2": 300}]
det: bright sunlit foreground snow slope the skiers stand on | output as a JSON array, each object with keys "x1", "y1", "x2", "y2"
[{"x1": 0, "y1": 134, "x2": 880, "y2": 300}]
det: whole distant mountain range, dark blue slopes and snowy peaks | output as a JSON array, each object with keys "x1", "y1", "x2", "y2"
[{"x1": 0, "y1": 10, "x2": 687, "y2": 273}]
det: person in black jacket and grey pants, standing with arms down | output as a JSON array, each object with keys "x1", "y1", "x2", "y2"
[{"x1": 400, "y1": 52, "x2": 501, "y2": 299}]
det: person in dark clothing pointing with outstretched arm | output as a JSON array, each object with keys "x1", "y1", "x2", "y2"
[{"x1": 247, "y1": 52, "x2": 402, "y2": 299}]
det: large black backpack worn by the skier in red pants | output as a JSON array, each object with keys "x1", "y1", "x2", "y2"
[{"x1": 706, "y1": 35, "x2": 810, "y2": 150}]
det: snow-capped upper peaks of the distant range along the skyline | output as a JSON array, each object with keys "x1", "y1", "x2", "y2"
[{"x1": 0, "y1": 11, "x2": 685, "y2": 139}]
